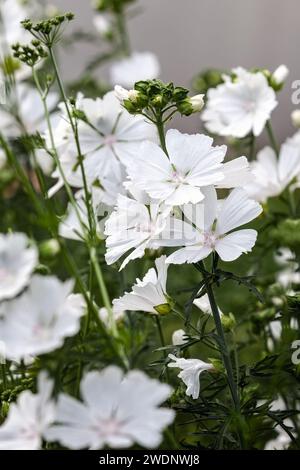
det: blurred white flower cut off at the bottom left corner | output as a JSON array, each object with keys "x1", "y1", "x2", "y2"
[{"x1": 0, "y1": 372, "x2": 55, "y2": 450}]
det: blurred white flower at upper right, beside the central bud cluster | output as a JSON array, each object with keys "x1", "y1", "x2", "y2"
[{"x1": 202, "y1": 67, "x2": 277, "y2": 138}]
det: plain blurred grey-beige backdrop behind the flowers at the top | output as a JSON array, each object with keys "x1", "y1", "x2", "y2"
[{"x1": 53, "y1": 0, "x2": 300, "y2": 141}]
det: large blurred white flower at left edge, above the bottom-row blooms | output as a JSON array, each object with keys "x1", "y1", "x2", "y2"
[{"x1": 0, "y1": 275, "x2": 85, "y2": 360}]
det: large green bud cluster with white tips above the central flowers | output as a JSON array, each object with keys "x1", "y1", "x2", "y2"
[{"x1": 115, "y1": 79, "x2": 204, "y2": 116}]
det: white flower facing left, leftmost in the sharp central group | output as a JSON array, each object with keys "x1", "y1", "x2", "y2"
[{"x1": 104, "y1": 195, "x2": 169, "y2": 269}]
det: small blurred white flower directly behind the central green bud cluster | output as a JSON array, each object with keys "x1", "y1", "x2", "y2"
[{"x1": 110, "y1": 52, "x2": 160, "y2": 88}]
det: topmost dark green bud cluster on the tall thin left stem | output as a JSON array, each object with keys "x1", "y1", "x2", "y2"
[{"x1": 21, "y1": 13, "x2": 74, "y2": 46}]
